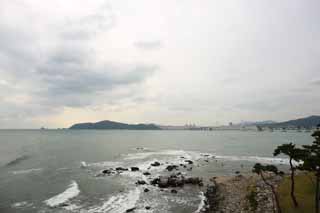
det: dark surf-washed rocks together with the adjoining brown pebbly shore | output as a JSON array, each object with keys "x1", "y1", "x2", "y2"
[{"x1": 97, "y1": 151, "x2": 279, "y2": 213}]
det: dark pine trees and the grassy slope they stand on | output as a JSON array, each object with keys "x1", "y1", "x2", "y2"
[{"x1": 252, "y1": 130, "x2": 320, "y2": 213}]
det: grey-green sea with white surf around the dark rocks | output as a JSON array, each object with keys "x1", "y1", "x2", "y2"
[{"x1": 0, "y1": 130, "x2": 312, "y2": 213}]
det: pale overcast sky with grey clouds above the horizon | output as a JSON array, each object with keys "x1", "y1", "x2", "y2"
[{"x1": 0, "y1": 0, "x2": 320, "y2": 128}]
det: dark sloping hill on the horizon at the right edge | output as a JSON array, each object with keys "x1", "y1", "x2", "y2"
[{"x1": 262, "y1": 115, "x2": 320, "y2": 128}]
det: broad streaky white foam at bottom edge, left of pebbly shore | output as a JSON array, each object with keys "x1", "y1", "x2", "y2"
[{"x1": 87, "y1": 188, "x2": 141, "y2": 213}]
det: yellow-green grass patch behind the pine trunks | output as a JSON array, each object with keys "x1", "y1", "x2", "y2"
[{"x1": 278, "y1": 173, "x2": 315, "y2": 213}]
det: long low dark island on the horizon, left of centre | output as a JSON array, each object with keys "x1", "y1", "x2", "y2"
[{"x1": 69, "y1": 120, "x2": 160, "y2": 130}]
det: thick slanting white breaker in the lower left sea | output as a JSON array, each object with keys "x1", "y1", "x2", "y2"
[{"x1": 44, "y1": 180, "x2": 80, "y2": 207}]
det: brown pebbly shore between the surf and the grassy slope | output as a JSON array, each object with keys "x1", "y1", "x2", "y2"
[{"x1": 202, "y1": 174, "x2": 282, "y2": 213}]
